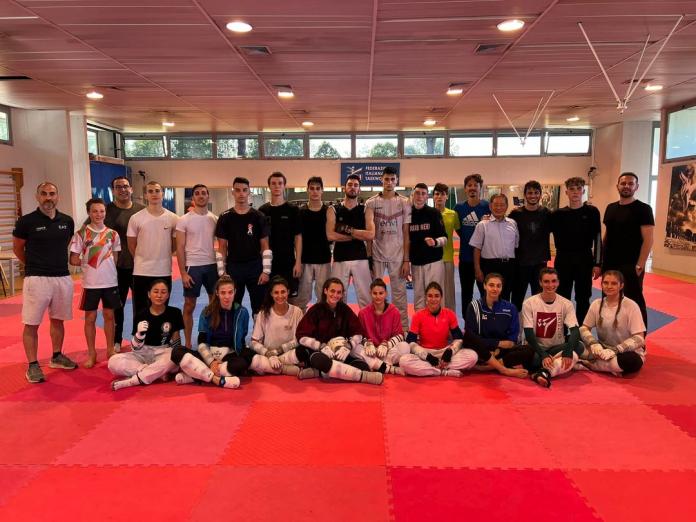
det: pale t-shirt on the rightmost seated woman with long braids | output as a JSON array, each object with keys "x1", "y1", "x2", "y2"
[{"x1": 583, "y1": 297, "x2": 645, "y2": 353}]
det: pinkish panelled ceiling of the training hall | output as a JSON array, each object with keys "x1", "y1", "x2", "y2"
[{"x1": 0, "y1": 0, "x2": 696, "y2": 132}]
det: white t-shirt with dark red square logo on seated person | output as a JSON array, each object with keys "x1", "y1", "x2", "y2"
[{"x1": 522, "y1": 294, "x2": 578, "y2": 348}]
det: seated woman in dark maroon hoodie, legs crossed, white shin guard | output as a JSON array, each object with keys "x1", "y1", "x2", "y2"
[{"x1": 295, "y1": 277, "x2": 383, "y2": 384}]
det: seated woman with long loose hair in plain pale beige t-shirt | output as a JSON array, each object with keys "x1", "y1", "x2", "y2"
[{"x1": 249, "y1": 277, "x2": 302, "y2": 376}]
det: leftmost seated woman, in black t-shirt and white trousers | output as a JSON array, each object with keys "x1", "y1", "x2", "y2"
[{"x1": 109, "y1": 279, "x2": 184, "y2": 391}]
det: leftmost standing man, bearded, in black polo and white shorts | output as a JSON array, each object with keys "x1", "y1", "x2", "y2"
[{"x1": 12, "y1": 181, "x2": 77, "y2": 383}]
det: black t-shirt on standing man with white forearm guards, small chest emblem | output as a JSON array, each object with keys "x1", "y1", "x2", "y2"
[{"x1": 215, "y1": 208, "x2": 269, "y2": 263}]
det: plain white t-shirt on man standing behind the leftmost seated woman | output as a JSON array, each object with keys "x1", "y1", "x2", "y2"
[{"x1": 128, "y1": 208, "x2": 179, "y2": 277}]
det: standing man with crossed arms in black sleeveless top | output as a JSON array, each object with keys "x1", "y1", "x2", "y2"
[{"x1": 326, "y1": 174, "x2": 375, "y2": 308}]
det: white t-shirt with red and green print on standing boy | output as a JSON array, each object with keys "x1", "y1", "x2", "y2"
[{"x1": 70, "y1": 225, "x2": 121, "y2": 288}]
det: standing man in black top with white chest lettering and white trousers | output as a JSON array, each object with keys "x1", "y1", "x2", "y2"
[{"x1": 409, "y1": 183, "x2": 447, "y2": 311}]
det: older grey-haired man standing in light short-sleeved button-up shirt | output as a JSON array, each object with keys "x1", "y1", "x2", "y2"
[{"x1": 469, "y1": 194, "x2": 520, "y2": 301}]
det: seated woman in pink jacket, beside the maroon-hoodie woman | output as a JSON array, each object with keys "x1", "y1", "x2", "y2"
[{"x1": 353, "y1": 279, "x2": 409, "y2": 375}]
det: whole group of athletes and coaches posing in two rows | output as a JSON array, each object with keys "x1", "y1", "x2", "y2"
[{"x1": 13, "y1": 167, "x2": 654, "y2": 390}]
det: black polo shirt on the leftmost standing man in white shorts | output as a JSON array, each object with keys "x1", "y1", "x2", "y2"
[{"x1": 12, "y1": 208, "x2": 75, "y2": 277}]
